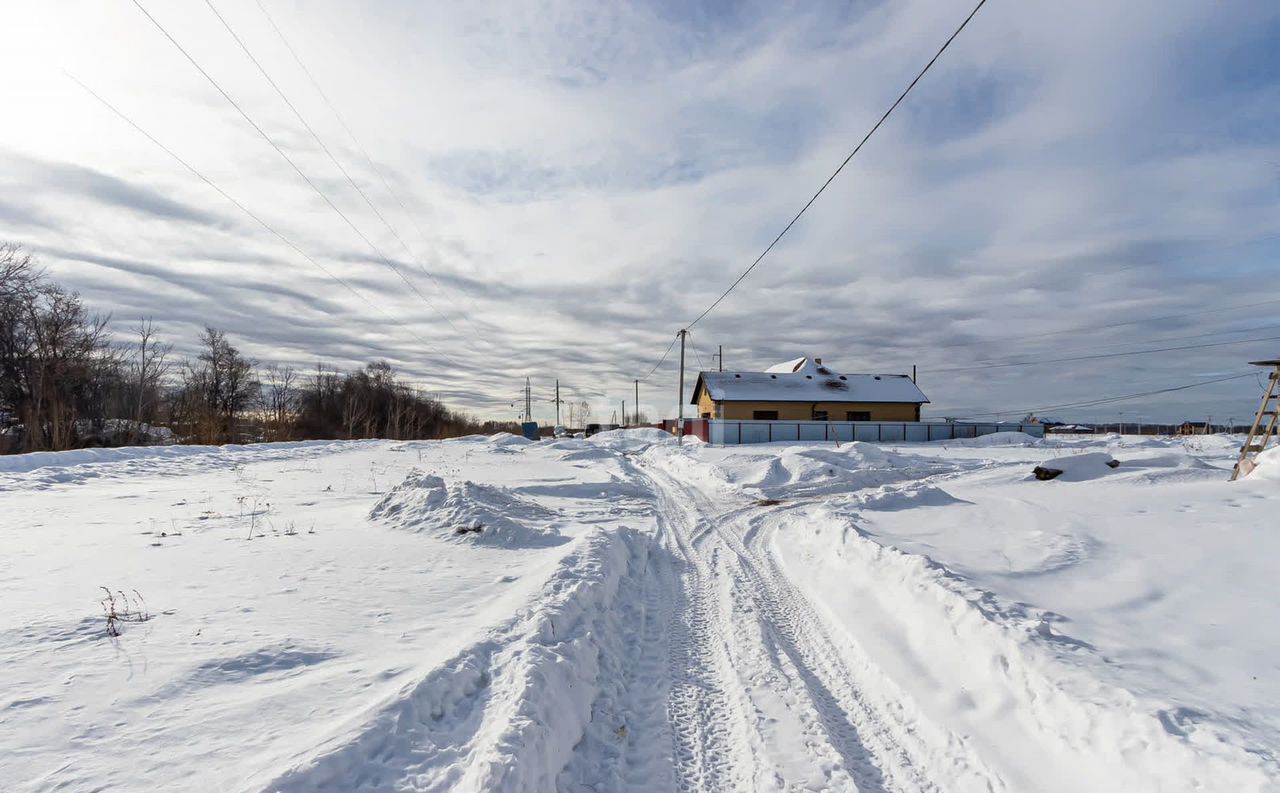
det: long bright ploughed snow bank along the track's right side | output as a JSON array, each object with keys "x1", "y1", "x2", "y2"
[{"x1": 778, "y1": 506, "x2": 1270, "y2": 792}]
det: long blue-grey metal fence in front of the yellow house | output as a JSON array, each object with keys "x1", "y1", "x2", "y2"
[{"x1": 708, "y1": 420, "x2": 1044, "y2": 445}]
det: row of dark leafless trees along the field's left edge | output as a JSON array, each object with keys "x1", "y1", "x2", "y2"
[{"x1": 0, "y1": 244, "x2": 515, "y2": 453}]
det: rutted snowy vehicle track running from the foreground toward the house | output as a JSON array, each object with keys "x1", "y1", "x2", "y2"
[{"x1": 634, "y1": 458, "x2": 1001, "y2": 793}]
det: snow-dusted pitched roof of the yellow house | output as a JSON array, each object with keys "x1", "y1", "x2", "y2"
[{"x1": 692, "y1": 358, "x2": 929, "y2": 404}]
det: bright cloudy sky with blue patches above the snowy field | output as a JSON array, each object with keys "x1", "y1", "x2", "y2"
[{"x1": 0, "y1": 0, "x2": 1280, "y2": 421}]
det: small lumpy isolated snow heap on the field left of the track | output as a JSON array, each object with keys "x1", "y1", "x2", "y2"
[{"x1": 369, "y1": 472, "x2": 567, "y2": 547}]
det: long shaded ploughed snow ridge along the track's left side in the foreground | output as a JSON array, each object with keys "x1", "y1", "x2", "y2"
[{"x1": 266, "y1": 530, "x2": 649, "y2": 793}]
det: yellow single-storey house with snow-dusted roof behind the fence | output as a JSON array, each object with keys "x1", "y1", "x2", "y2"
[{"x1": 691, "y1": 358, "x2": 929, "y2": 421}]
